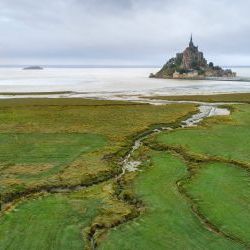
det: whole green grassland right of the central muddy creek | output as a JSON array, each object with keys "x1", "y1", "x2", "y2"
[{"x1": 100, "y1": 98, "x2": 250, "y2": 249}]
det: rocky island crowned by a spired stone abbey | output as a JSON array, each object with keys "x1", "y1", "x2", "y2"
[{"x1": 149, "y1": 35, "x2": 236, "y2": 79}]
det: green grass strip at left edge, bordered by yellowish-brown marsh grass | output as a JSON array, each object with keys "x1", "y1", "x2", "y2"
[{"x1": 0, "y1": 133, "x2": 106, "y2": 168}]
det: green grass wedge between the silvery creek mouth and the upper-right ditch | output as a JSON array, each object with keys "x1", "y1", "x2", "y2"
[{"x1": 158, "y1": 105, "x2": 250, "y2": 163}]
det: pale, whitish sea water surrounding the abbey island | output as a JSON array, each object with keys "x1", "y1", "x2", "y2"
[{"x1": 0, "y1": 67, "x2": 250, "y2": 98}]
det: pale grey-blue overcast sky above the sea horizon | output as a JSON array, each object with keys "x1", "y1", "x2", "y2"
[{"x1": 0, "y1": 0, "x2": 250, "y2": 65}]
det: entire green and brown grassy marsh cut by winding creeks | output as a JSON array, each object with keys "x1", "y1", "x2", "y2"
[{"x1": 0, "y1": 95, "x2": 250, "y2": 250}]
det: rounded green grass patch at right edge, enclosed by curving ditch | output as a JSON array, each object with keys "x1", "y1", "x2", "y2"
[{"x1": 185, "y1": 163, "x2": 250, "y2": 245}]
